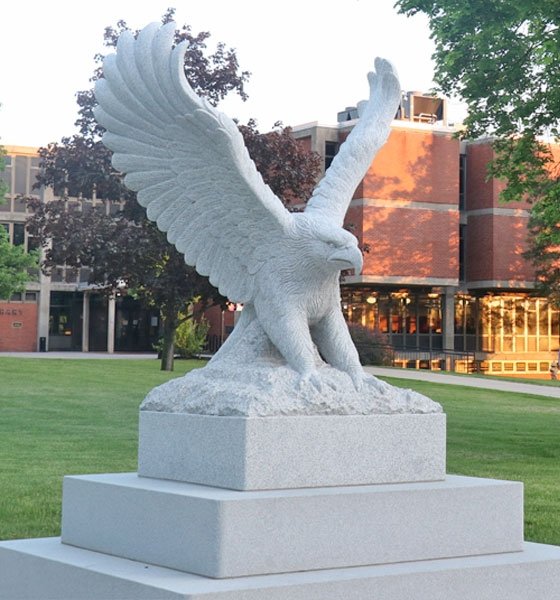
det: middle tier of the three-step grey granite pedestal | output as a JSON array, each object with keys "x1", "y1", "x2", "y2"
[{"x1": 62, "y1": 473, "x2": 523, "y2": 577}]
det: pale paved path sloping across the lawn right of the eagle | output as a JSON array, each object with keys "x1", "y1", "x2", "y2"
[{"x1": 365, "y1": 367, "x2": 560, "y2": 398}]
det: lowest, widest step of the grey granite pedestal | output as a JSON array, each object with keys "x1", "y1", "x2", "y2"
[{"x1": 0, "y1": 538, "x2": 560, "y2": 600}]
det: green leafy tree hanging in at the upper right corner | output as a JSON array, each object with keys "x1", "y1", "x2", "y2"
[{"x1": 396, "y1": 0, "x2": 560, "y2": 302}]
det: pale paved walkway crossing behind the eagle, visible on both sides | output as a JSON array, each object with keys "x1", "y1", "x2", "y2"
[{"x1": 0, "y1": 352, "x2": 560, "y2": 398}]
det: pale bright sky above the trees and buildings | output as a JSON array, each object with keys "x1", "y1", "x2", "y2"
[{"x1": 0, "y1": 0, "x2": 461, "y2": 147}]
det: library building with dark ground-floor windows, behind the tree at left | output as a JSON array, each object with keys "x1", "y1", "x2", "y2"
[{"x1": 0, "y1": 146, "x2": 163, "y2": 352}]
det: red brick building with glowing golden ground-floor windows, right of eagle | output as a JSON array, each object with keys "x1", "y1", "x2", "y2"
[{"x1": 294, "y1": 92, "x2": 560, "y2": 376}]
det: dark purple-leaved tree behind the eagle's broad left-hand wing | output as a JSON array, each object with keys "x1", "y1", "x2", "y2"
[{"x1": 28, "y1": 9, "x2": 319, "y2": 370}]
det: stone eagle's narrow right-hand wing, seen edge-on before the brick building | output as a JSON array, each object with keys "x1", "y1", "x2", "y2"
[{"x1": 305, "y1": 58, "x2": 401, "y2": 227}]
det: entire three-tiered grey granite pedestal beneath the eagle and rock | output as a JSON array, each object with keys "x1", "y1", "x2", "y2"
[{"x1": 0, "y1": 413, "x2": 560, "y2": 600}]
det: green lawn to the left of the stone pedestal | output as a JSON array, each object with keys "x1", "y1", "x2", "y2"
[{"x1": 0, "y1": 358, "x2": 204, "y2": 539}]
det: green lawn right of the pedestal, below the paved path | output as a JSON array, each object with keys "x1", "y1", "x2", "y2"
[{"x1": 387, "y1": 378, "x2": 560, "y2": 545}]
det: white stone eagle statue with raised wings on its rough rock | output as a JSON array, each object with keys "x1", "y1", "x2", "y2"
[{"x1": 95, "y1": 23, "x2": 440, "y2": 415}]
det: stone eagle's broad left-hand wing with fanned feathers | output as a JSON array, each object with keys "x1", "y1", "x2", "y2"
[{"x1": 95, "y1": 23, "x2": 293, "y2": 302}]
